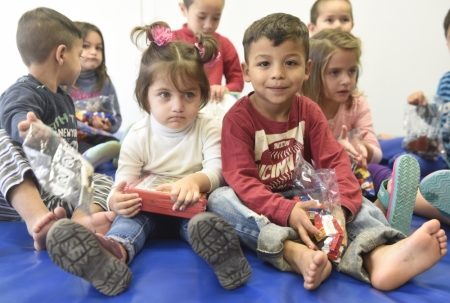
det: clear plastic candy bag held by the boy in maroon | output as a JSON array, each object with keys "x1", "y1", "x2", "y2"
[{"x1": 292, "y1": 155, "x2": 345, "y2": 263}]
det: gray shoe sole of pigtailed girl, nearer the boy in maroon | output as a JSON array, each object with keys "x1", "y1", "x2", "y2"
[{"x1": 188, "y1": 212, "x2": 252, "y2": 290}]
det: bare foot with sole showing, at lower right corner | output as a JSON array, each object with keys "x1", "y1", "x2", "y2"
[{"x1": 363, "y1": 220, "x2": 447, "y2": 291}]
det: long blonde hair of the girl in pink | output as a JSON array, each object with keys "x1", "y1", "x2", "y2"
[{"x1": 301, "y1": 29, "x2": 361, "y2": 108}]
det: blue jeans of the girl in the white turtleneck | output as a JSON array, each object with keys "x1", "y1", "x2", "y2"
[{"x1": 105, "y1": 212, "x2": 189, "y2": 264}]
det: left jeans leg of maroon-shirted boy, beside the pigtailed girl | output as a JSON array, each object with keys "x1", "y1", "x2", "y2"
[{"x1": 208, "y1": 186, "x2": 301, "y2": 271}]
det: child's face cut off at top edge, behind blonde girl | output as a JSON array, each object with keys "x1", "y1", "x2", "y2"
[{"x1": 308, "y1": 0, "x2": 354, "y2": 35}]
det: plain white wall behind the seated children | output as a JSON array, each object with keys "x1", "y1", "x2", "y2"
[{"x1": 0, "y1": 0, "x2": 450, "y2": 135}]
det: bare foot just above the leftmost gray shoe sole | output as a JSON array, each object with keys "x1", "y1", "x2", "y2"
[{"x1": 72, "y1": 204, "x2": 116, "y2": 235}]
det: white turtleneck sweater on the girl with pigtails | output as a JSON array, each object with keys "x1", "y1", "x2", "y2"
[{"x1": 108, "y1": 114, "x2": 224, "y2": 209}]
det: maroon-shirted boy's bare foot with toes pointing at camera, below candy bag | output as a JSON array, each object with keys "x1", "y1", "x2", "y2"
[{"x1": 283, "y1": 240, "x2": 331, "y2": 289}]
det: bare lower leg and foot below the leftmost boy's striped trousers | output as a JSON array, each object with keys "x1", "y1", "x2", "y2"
[{"x1": 8, "y1": 177, "x2": 66, "y2": 250}]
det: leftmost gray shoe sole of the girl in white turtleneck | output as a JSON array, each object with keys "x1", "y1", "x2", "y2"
[{"x1": 47, "y1": 219, "x2": 132, "y2": 296}]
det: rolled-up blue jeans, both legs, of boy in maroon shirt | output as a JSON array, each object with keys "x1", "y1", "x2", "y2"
[{"x1": 208, "y1": 186, "x2": 406, "y2": 283}]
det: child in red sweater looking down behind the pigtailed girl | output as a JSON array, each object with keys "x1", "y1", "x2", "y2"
[{"x1": 173, "y1": 0, "x2": 244, "y2": 101}]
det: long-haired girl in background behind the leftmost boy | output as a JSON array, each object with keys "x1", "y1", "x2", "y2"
[{"x1": 67, "y1": 22, "x2": 122, "y2": 167}]
